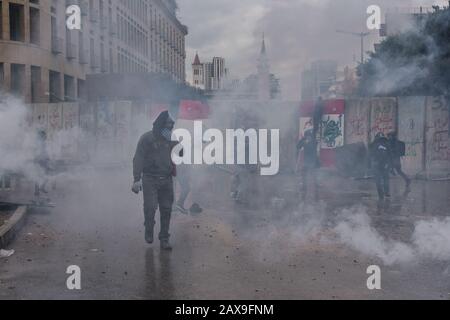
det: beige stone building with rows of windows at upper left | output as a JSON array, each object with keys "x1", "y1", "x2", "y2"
[{"x1": 0, "y1": 0, "x2": 188, "y2": 103}]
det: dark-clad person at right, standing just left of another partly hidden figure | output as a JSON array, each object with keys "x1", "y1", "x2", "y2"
[{"x1": 369, "y1": 132, "x2": 391, "y2": 200}]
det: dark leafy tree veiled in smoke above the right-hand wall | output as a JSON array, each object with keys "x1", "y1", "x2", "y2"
[{"x1": 358, "y1": 8, "x2": 450, "y2": 96}]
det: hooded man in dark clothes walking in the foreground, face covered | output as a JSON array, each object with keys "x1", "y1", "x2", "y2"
[{"x1": 132, "y1": 111, "x2": 178, "y2": 250}]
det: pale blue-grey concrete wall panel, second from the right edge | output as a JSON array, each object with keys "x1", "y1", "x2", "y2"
[{"x1": 398, "y1": 97, "x2": 426, "y2": 175}]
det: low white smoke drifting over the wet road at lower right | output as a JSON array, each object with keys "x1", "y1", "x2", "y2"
[{"x1": 241, "y1": 202, "x2": 450, "y2": 266}]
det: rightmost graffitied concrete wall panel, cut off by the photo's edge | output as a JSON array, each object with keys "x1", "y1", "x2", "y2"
[{"x1": 425, "y1": 97, "x2": 450, "y2": 173}]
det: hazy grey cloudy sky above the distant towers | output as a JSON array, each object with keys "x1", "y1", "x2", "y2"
[{"x1": 178, "y1": 0, "x2": 448, "y2": 100}]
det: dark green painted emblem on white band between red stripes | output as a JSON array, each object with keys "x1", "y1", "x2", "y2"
[{"x1": 321, "y1": 114, "x2": 344, "y2": 149}]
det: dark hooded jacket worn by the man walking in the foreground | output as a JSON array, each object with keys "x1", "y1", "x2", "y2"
[{"x1": 133, "y1": 111, "x2": 178, "y2": 181}]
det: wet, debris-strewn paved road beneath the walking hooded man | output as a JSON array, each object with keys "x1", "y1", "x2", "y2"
[{"x1": 0, "y1": 171, "x2": 450, "y2": 299}]
